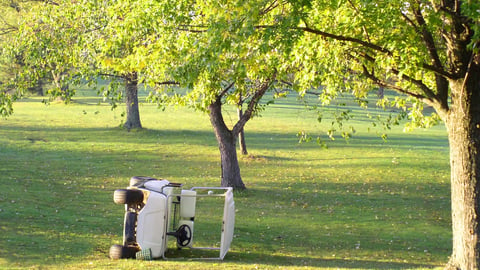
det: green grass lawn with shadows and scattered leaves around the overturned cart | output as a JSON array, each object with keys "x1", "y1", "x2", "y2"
[{"x1": 0, "y1": 93, "x2": 451, "y2": 269}]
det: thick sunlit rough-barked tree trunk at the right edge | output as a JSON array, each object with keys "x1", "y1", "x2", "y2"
[{"x1": 445, "y1": 77, "x2": 480, "y2": 270}]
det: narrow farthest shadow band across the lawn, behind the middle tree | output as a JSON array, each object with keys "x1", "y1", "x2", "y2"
[{"x1": 2, "y1": 123, "x2": 448, "y2": 150}]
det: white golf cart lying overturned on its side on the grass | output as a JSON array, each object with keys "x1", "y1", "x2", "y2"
[{"x1": 109, "y1": 176, "x2": 235, "y2": 260}]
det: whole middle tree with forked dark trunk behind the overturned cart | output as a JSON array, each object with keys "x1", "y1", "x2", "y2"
[{"x1": 136, "y1": 0, "x2": 296, "y2": 189}]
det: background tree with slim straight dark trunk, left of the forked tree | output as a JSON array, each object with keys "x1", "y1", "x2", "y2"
[{"x1": 88, "y1": 1, "x2": 152, "y2": 130}]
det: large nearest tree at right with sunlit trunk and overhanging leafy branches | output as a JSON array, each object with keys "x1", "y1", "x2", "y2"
[{"x1": 270, "y1": 0, "x2": 480, "y2": 269}]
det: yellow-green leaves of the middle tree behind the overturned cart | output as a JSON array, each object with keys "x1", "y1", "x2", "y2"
[{"x1": 138, "y1": 1, "x2": 300, "y2": 116}]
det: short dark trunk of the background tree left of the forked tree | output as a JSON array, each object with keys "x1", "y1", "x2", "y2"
[{"x1": 123, "y1": 72, "x2": 142, "y2": 130}]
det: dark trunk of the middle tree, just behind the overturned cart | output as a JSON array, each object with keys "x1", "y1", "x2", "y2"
[{"x1": 209, "y1": 100, "x2": 245, "y2": 189}]
